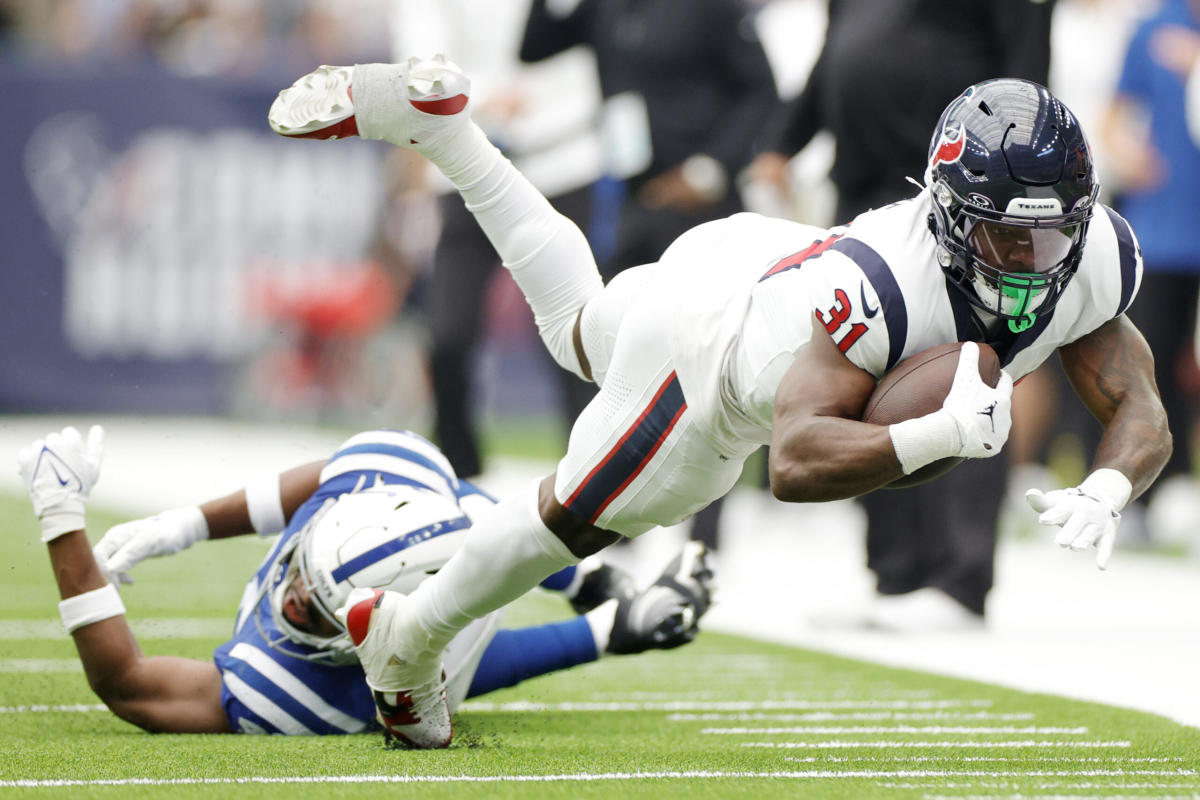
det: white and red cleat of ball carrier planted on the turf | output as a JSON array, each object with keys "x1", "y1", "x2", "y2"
[{"x1": 336, "y1": 589, "x2": 454, "y2": 750}]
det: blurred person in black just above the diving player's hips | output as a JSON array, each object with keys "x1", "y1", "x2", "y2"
[{"x1": 521, "y1": 0, "x2": 778, "y2": 549}]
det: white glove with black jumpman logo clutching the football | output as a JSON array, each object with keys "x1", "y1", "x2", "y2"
[{"x1": 942, "y1": 342, "x2": 1013, "y2": 458}]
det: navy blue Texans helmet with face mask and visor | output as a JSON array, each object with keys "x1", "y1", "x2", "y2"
[{"x1": 925, "y1": 78, "x2": 1099, "y2": 333}]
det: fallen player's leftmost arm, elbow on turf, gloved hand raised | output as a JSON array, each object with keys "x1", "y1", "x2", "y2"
[{"x1": 18, "y1": 426, "x2": 229, "y2": 733}]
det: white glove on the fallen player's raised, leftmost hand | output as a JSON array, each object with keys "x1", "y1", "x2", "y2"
[{"x1": 17, "y1": 425, "x2": 104, "y2": 542}]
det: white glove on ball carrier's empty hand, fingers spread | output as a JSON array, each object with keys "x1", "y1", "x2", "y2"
[{"x1": 1025, "y1": 469, "x2": 1133, "y2": 570}]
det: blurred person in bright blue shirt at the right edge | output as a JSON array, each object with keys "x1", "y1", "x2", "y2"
[{"x1": 1100, "y1": 0, "x2": 1200, "y2": 544}]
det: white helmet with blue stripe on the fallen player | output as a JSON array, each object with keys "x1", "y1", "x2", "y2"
[{"x1": 254, "y1": 483, "x2": 470, "y2": 663}]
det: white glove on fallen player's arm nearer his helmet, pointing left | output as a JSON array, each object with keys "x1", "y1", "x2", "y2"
[{"x1": 92, "y1": 506, "x2": 209, "y2": 583}]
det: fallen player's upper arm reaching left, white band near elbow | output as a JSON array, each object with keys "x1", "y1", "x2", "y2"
[{"x1": 95, "y1": 462, "x2": 325, "y2": 583}]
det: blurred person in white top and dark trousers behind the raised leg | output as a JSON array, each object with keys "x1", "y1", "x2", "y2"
[{"x1": 391, "y1": 0, "x2": 601, "y2": 477}]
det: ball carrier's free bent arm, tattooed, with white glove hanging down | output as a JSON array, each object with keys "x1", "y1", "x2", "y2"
[{"x1": 1026, "y1": 317, "x2": 1171, "y2": 570}]
